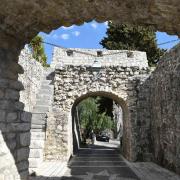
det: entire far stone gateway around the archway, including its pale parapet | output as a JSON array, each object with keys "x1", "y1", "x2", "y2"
[{"x1": 45, "y1": 48, "x2": 150, "y2": 165}]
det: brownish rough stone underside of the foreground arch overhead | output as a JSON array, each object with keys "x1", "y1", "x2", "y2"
[{"x1": 0, "y1": 0, "x2": 180, "y2": 42}]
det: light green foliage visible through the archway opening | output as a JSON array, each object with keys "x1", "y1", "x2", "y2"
[{"x1": 78, "y1": 97, "x2": 114, "y2": 133}]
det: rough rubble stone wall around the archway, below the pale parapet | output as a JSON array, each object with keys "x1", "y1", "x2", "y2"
[{"x1": 45, "y1": 65, "x2": 149, "y2": 160}]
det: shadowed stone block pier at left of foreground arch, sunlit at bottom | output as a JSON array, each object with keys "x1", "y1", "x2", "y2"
[{"x1": 0, "y1": 34, "x2": 31, "y2": 180}]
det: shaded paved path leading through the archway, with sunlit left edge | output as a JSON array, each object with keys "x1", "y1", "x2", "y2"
[{"x1": 30, "y1": 141, "x2": 180, "y2": 180}]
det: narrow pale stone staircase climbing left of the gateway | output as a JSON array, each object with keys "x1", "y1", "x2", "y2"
[{"x1": 29, "y1": 68, "x2": 54, "y2": 173}]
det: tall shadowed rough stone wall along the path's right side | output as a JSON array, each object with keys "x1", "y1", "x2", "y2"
[{"x1": 149, "y1": 45, "x2": 180, "y2": 173}]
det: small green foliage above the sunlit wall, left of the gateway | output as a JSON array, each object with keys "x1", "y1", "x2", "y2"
[{"x1": 29, "y1": 35, "x2": 49, "y2": 67}]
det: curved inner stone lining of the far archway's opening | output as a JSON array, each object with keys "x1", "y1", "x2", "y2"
[{"x1": 71, "y1": 91, "x2": 131, "y2": 157}]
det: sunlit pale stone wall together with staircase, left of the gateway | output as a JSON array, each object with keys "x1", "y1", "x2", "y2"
[{"x1": 19, "y1": 47, "x2": 53, "y2": 172}]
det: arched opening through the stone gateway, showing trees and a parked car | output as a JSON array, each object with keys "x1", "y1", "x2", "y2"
[{"x1": 72, "y1": 92, "x2": 127, "y2": 154}]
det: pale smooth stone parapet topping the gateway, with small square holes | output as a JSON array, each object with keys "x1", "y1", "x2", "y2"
[{"x1": 51, "y1": 48, "x2": 148, "y2": 68}]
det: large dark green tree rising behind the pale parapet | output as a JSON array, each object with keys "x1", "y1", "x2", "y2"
[{"x1": 100, "y1": 22, "x2": 165, "y2": 66}]
